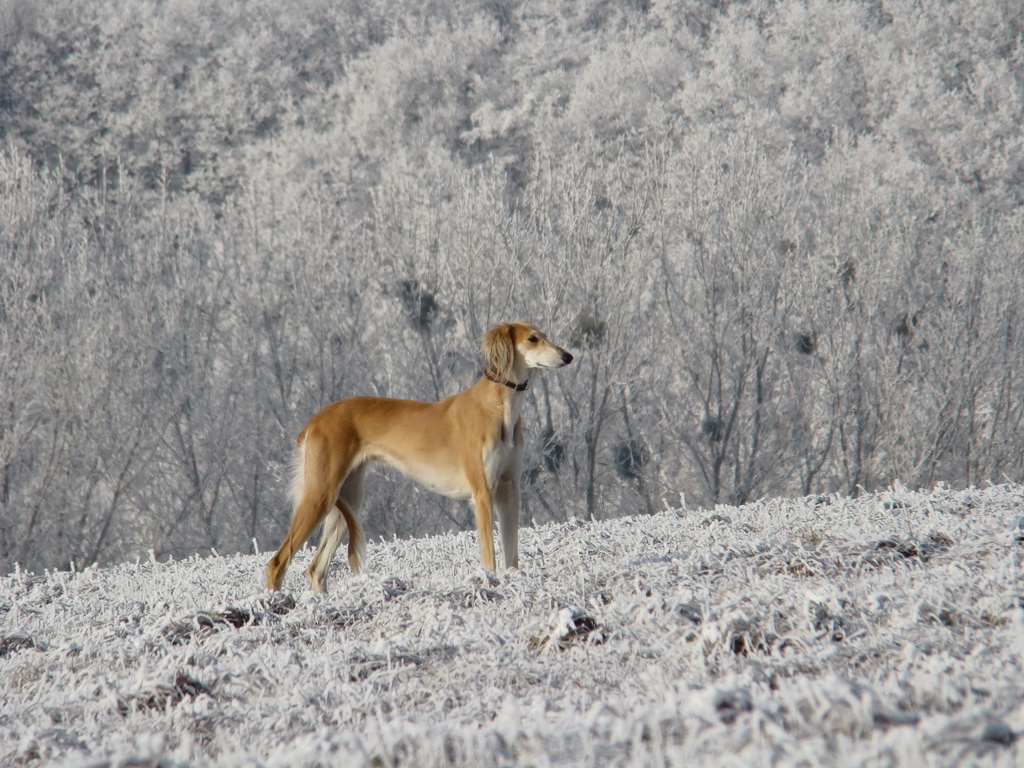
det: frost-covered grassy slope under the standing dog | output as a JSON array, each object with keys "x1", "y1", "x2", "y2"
[{"x1": 0, "y1": 485, "x2": 1024, "y2": 768}]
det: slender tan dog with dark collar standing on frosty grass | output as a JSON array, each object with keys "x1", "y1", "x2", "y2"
[{"x1": 266, "y1": 323, "x2": 572, "y2": 592}]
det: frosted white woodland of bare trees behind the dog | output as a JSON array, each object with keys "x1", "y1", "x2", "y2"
[{"x1": 0, "y1": 0, "x2": 1024, "y2": 572}]
